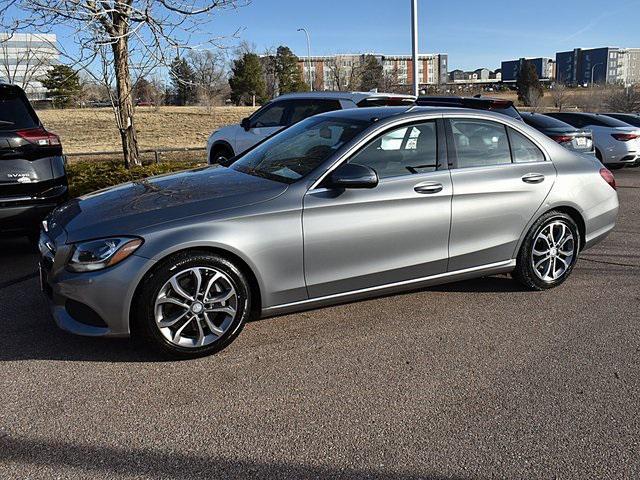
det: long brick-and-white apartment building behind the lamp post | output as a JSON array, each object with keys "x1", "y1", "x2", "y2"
[{"x1": 298, "y1": 53, "x2": 448, "y2": 90}]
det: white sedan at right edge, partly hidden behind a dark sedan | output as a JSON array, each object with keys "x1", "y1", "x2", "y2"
[{"x1": 546, "y1": 112, "x2": 640, "y2": 169}]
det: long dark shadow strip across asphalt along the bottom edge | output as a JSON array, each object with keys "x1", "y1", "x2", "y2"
[{"x1": 0, "y1": 432, "x2": 462, "y2": 480}]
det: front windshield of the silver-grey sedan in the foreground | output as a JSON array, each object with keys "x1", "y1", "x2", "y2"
[{"x1": 231, "y1": 116, "x2": 371, "y2": 183}]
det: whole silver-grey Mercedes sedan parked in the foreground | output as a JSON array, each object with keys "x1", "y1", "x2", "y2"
[{"x1": 40, "y1": 107, "x2": 618, "y2": 357}]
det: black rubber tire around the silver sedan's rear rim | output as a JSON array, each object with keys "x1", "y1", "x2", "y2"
[{"x1": 512, "y1": 211, "x2": 580, "y2": 290}]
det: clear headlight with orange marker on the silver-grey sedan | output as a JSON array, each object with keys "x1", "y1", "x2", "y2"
[{"x1": 67, "y1": 237, "x2": 142, "y2": 272}]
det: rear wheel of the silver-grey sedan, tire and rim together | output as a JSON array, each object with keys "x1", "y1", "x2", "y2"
[{"x1": 513, "y1": 212, "x2": 580, "y2": 290}]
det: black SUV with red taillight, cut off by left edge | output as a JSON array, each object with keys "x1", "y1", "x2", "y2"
[{"x1": 0, "y1": 83, "x2": 68, "y2": 239}]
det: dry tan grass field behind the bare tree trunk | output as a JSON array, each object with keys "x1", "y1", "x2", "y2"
[{"x1": 38, "y1": 107, "x2": 254, "y2": 153}]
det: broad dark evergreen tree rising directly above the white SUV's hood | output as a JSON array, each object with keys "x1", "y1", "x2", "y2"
[{"x1": 229, "y1": 53, "x2": 268, "y2": 105}]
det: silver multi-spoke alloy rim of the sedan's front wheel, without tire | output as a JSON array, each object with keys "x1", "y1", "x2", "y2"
[{"x1": 154, "y1": 267, "x2": 238, "y2": 348}]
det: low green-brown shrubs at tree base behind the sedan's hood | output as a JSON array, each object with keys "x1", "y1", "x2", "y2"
[{"x1": 67, "y1": 162, "x2": 202, "y2": 197}]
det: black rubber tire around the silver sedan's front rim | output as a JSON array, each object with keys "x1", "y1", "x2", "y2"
[{"x1": 131, "y1": 250, "x2": 251, "y2": 359}]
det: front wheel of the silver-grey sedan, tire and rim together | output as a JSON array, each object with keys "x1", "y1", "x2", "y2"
[{"x1": 132, "y1": 252, "x2": 251, "y2": 358}]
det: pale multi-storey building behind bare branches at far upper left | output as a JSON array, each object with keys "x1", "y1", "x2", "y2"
[{"x1": 0, "y1": 33, "x2": 58, "y2": 100}]
